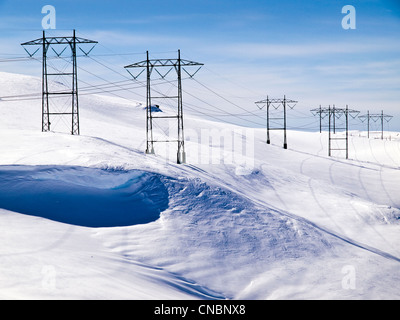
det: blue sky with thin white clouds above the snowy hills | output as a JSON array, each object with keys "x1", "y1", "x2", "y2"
[{"x1": 0, "y1": 0, "x2": 400, "y2": 131}]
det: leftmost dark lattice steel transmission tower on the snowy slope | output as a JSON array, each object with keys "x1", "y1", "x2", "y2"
[{"x1": 21, "y1": 30, "x2": 97, "y2": 135}]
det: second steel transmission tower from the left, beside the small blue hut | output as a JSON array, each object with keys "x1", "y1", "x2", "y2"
[{"x1": 125, "y1": 50, "x2": 204, "y2": 164}]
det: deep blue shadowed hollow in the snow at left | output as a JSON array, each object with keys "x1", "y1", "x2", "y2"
[{"x1": 0, "y1": 166, "x2": 168, "y2": 227}]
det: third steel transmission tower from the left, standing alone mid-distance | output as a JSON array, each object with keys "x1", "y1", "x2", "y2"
[{"x1": 255, "y1": 96, "x2": 298, "y2": 149}]
